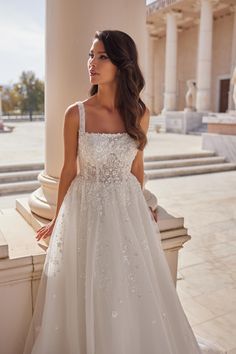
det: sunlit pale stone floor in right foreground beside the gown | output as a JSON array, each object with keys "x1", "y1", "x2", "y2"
[{"x1": 147, "y1": 171, "x2": 236, "y2": 354}]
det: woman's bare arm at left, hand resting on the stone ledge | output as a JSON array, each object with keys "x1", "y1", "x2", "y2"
[{"x1": 36, "y1": 104, "x2": 79, "y2": 240}]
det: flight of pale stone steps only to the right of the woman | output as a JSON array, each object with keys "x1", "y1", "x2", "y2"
[{"x1": 144, "y1": 151, "x2": 236, "y2": 179}]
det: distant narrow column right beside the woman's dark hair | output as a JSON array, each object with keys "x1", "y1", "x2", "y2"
[{"x1": 145, "y1": 24, "x2": 157, "y2": 114}]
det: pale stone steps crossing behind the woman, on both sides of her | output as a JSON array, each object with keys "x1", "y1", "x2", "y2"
[{"x1": 0, "y1": 151, "x2": 236, "y2": 196}]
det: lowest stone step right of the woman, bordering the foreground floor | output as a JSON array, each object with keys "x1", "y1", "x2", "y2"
[{"x1": 146, "y1": 163, "x2": 236, "y2": 180}]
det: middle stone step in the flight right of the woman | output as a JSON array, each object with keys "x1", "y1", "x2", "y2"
[{"x1": 144, "y1": 156, "x2": 225, "y2": 170}]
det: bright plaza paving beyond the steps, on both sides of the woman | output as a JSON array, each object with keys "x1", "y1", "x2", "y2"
[{"x1": 0, "y1": 121, "x2": 204, "y2": 165}]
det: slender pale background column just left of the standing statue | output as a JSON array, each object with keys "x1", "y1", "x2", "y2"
[{"x1": 163, "y1": 11, "x2": 179, "y2": 112}]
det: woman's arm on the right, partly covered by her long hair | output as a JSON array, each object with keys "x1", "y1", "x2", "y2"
[{"x1": 131, "y1": 108, "x2": 150, "y2": 189}]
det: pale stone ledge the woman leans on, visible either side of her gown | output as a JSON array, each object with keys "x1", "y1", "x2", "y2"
[{"x1": 0, "y1": 198, "x2": 191, "y2": 286}]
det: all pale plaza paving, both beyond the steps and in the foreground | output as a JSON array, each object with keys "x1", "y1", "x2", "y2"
[{"x1": 0, "y1": 122, "x2": 236, "y2": 354}]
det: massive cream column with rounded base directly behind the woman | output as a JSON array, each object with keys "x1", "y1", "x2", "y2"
[{"x1": 29, "y1": 0, "x2": 146, "y2": 219}]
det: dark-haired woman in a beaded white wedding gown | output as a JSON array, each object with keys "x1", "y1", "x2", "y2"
[{"x1": 24, "y1": 31, "x2": 225, "y2": 354}]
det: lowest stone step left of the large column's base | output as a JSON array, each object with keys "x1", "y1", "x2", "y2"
[{"x1": 0, "y1": 181, "x2": 40, "y2": 196}]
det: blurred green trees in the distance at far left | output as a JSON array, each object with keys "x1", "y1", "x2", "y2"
[{"x1": 2, "y1": 71, "x2": 44, "y2": 120}]
